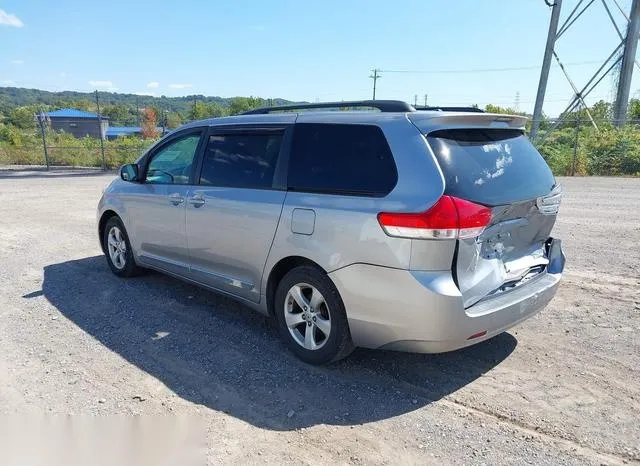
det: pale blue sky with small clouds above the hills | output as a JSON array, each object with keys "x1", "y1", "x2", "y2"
[{"x1": 0, "y1": 0, "x2": 640, "y2": 116}]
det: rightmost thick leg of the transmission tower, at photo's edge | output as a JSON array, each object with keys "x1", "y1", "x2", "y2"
[{"x1": 613, "y1": 0, "x2": 640, "y2": 127}]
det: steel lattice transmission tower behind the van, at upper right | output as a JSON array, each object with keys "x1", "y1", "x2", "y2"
[{"x1": 531, "y1": 0, "x2": 640, "y2": 139}]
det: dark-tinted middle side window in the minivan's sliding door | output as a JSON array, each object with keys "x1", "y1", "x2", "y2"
[{"x1": 200, "y1": 132, "x2": 283, "y2": 189}]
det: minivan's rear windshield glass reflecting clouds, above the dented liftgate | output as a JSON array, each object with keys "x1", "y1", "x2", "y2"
[{"x1": 427, "y1": 129, "x2": 555, "y2": 206}]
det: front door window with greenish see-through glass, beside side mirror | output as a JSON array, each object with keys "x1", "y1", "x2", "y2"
[{"x1": 145, "y1": 134, "x2": 200, "y2": 184}]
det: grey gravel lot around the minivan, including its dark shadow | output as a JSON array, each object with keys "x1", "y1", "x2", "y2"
[{"x1": 0, "y1": 171, "x2": 640, "y2": 464}]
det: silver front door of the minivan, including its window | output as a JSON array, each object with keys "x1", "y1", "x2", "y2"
[{"x1": 126, "y1": 129, "x2": 203, "y2": 275}]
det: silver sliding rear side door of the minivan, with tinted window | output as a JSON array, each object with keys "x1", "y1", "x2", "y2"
[{"x1": 186, "y1": 125, "x2": 288, "y2": 302}]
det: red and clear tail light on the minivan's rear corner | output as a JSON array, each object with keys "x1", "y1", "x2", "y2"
[{"x1": 378, "y1": 196, "x2": 491, "y2": 239}]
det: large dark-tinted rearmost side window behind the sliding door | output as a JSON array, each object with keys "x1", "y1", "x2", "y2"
[{"x1": 288, "y1": 123, "x2": 398, "y2": 197}]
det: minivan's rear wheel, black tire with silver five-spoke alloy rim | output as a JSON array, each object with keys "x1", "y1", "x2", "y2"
[{"x1": 274, "y1": 266, "x2": 354, "y2": 365}]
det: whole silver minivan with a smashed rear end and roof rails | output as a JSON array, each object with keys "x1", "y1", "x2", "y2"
[{"x1": 98, "y1": 100, "x2": 564, "y2": 364}]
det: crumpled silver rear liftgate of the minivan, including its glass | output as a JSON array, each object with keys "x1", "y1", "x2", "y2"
[{"x1": 427, "y1": 128, "x2": 561, "y2": 307}]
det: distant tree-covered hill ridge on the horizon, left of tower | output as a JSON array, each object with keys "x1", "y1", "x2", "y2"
[{"x1": 0, "y1": 87, "x2": 293, "y2": 114}]
